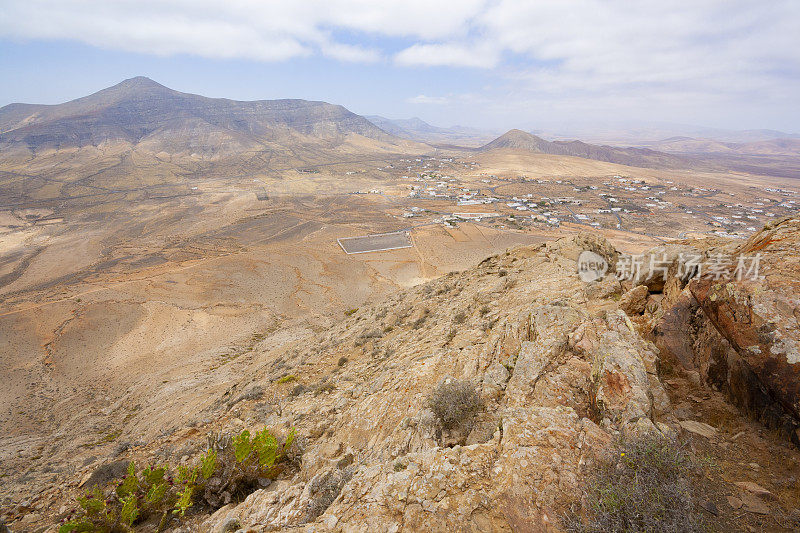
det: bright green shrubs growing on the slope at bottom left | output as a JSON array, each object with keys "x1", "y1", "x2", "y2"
[{"x1": 58, "y1": 429, "x2": 295, "y2": 533}]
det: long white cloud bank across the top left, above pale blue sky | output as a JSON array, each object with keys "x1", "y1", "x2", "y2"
[{"x1": 0, "y1": 0, "x2": 483, "y2": 62}]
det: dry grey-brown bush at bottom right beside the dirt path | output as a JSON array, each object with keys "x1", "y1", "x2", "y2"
[{"x1": 565, "y1": 436, "x2": 707, "y2": 533}]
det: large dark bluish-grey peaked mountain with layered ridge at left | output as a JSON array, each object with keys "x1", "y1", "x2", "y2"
[{"x1": 0, "y1": 77, "x2": 410, "y2": 153}]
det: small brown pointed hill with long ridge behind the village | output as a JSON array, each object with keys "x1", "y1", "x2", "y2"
[{"x1": 480, "y1": 129, "x2": 686, "y2": 167}]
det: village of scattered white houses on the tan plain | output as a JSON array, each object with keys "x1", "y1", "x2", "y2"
[{"x1": 356, "y1": 157, "x2": 800, "y2": 239}]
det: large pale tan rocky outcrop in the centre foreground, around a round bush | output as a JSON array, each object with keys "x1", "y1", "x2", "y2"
[{"x1": 191, "y1": 236, "x2": 670, "y2": 532}]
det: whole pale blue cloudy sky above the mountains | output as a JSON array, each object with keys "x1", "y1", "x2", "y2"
[{"x1": 0, "y1": 0, "x2": 800, "y2": 132}]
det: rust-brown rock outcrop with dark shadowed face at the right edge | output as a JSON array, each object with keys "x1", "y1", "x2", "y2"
[{"x1": 653, "y1": 219, "x2": 800, "y2": 444}]
